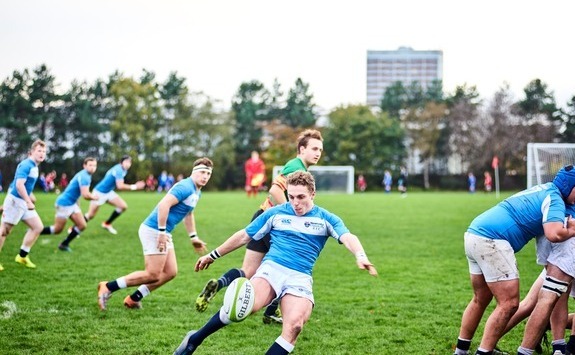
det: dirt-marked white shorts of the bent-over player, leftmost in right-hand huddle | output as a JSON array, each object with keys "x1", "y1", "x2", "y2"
[{"x1": 464, "y1": 232, "x2": 519, "y2": 282}]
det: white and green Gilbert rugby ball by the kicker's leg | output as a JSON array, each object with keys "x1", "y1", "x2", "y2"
[{"x1": 222, "y1": 277, "x2": 256, "y2": 322}]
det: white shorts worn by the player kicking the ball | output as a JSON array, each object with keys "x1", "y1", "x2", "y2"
[{"x1": 252, "y1": 260, "x2": 315, "y2": 304}]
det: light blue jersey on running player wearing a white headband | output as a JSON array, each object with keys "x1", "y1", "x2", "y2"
[{"x1": 144, "y1": 177, "x2": 202, "y2": 233}]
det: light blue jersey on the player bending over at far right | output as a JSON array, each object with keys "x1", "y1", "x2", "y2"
[{"x1": 467, "y1": 182, "x2": 565, "y2": 253}]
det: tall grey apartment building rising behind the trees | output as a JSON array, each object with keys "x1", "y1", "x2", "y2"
[{"x1": 367, "y1": 47, "x2": 443, "y2": 106}]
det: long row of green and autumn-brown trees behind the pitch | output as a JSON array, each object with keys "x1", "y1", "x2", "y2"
[{"x1": 0, "y1": 65, "x2": 575, "y2": 190}]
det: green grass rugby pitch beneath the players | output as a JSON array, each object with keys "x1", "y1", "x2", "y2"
[{"x1": 0, "y1": 192, "x2": 560, "y2": 354}]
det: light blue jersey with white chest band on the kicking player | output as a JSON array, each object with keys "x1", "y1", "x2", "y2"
[{"x1": 246, "y1": 202, "x2": 349, "y2": 276}]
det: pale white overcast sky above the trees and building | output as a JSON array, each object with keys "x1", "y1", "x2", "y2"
[{"x1": 0, "y1": 0, "x2": 575, "y2": 110}]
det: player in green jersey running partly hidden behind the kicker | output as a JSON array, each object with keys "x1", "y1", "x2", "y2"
[{"x1": 196, "y1": 129, "x2": 323, "y2": 324}]
